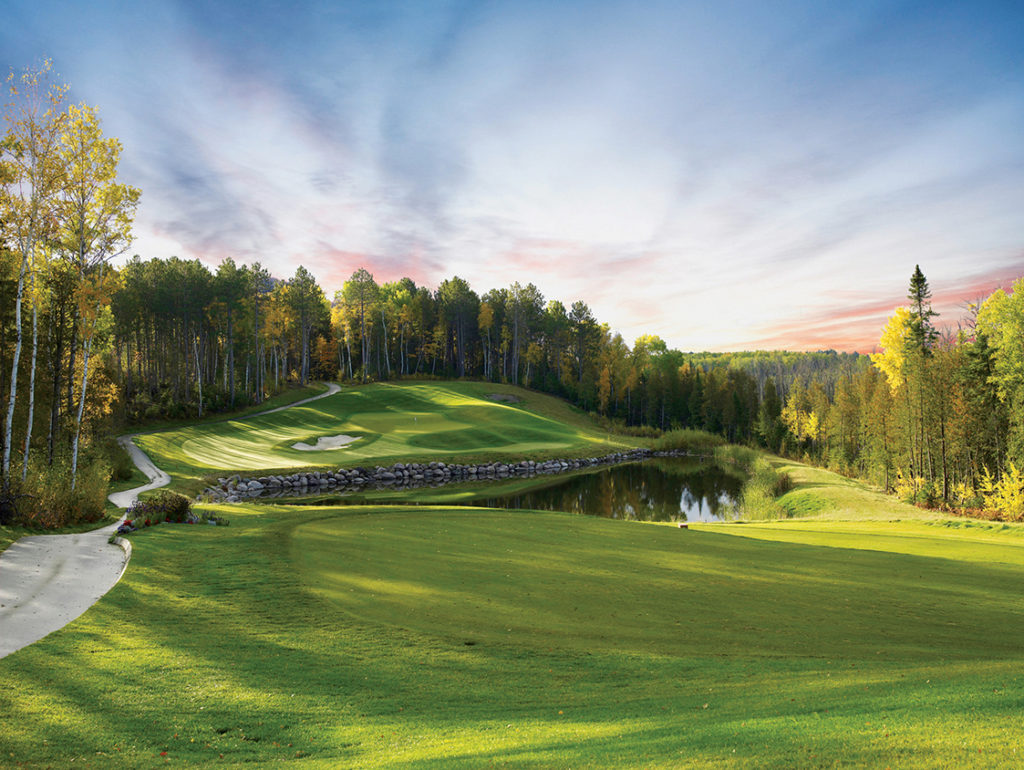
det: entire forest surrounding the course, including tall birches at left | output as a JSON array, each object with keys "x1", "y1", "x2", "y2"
[{"x1": 0, "y1": 68, "x2": 1024, "y2": 523}]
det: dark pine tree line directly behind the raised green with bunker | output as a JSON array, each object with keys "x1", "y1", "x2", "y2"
[{"x1": 110, "y1": 257, "x2": 786, "y2": 441}]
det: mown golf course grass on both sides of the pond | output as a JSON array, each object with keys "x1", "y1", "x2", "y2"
[{"x1": 0, "y1": 382, "x2": 1024, "y2": 768}]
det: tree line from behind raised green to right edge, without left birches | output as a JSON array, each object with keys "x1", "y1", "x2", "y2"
[{"x1": 103, "y1": 258, "x2": 1024, "y2": 518}]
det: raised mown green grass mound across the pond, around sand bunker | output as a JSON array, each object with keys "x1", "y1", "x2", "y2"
[{"x1": 137, "y1": 382, "x2": 636, "y2": 488}]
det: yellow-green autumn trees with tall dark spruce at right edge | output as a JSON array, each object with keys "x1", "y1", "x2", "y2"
[{"x1": 759, "y1": 266, "x2": 1024, "y2": 519}]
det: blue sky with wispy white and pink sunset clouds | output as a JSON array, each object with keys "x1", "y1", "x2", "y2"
[{"x1": 0, "y1": 0, "x2": 1024, "y2": 352}]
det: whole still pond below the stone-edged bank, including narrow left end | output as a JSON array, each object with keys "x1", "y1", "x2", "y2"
[{"x1": 280, "y1": 458, "x2": 743, "y2": 521}]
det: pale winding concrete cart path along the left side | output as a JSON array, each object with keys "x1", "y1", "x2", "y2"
[{"x1": 0, "y1": 383, "x2": 341, "y2": 657}]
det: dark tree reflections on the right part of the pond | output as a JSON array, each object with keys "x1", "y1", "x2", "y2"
[{"x1": 460, "y1": 458, "x2": 742, "y2": 521}]
